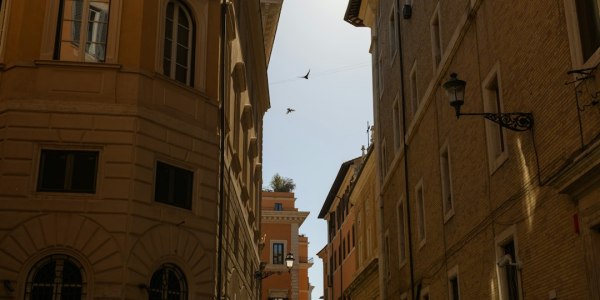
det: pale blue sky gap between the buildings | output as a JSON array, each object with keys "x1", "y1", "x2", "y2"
[{"x1": 263, "y1": 0, "x2": 373, "y2": 299}]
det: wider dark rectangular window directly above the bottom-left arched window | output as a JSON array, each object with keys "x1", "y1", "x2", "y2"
[{"x1": 37, "y1": 149, "x2": 98, "y2": 193}]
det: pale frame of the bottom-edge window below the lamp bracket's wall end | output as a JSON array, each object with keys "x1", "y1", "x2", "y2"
[{"x1": 495, "y1": 225, "x2": 523, "y2": 300}]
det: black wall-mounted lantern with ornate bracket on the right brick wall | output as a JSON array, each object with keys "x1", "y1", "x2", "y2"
[{"x1": 444, "y1": 73, "x2": 533, "y2": 131}]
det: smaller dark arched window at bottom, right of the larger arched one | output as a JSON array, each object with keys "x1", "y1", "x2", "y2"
[{"x1": 148, "y1": 264, "x2": 188, "y2": 300}]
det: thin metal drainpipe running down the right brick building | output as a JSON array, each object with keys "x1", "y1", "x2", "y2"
[{"x1": 396, "y1": 0, "x2": 417, "y2": 300}]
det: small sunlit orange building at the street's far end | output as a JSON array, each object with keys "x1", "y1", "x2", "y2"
[{"x1": 256, "y1": 192, "x2": 313, "y2": 300}]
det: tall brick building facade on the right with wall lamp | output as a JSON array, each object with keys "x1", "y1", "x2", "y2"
[{"x1": 345, "y1": 0, "x2": 600, "y2": 299}]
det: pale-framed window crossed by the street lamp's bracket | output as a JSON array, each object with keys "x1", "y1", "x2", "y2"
[{"x1": 481, "y1": 64, "x2": 508, "y2": 174}]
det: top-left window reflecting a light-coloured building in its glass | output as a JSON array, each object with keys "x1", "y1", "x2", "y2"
[{"x1": 54, "y1": 0, "x2": 110, "y2": 62}]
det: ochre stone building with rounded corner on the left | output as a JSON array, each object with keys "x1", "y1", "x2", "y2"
[{"x1": 0, "y1": 0, "x2": 281, "y2": 299}]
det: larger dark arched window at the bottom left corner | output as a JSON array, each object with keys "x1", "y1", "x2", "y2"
[{"x1": 25, "y1": 255, "x2": 86, "y2": 300}]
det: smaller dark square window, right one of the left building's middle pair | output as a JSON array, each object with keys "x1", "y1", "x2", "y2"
[{"x1": 154, "y1": 161, "x2": 194, "y2": 209}]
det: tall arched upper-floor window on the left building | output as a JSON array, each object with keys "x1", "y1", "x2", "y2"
[{"x1": 163, "y1": 1, "x2": 195, "y2": 86}]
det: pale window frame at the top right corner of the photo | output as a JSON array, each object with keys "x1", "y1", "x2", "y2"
[{"x1": 563, "y1": 0, "x2": 600, "y2": 69}]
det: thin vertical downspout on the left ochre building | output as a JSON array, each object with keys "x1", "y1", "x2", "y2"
[{"x1": 216, "y1": 0, "x2": 227, "y2": 300}]
